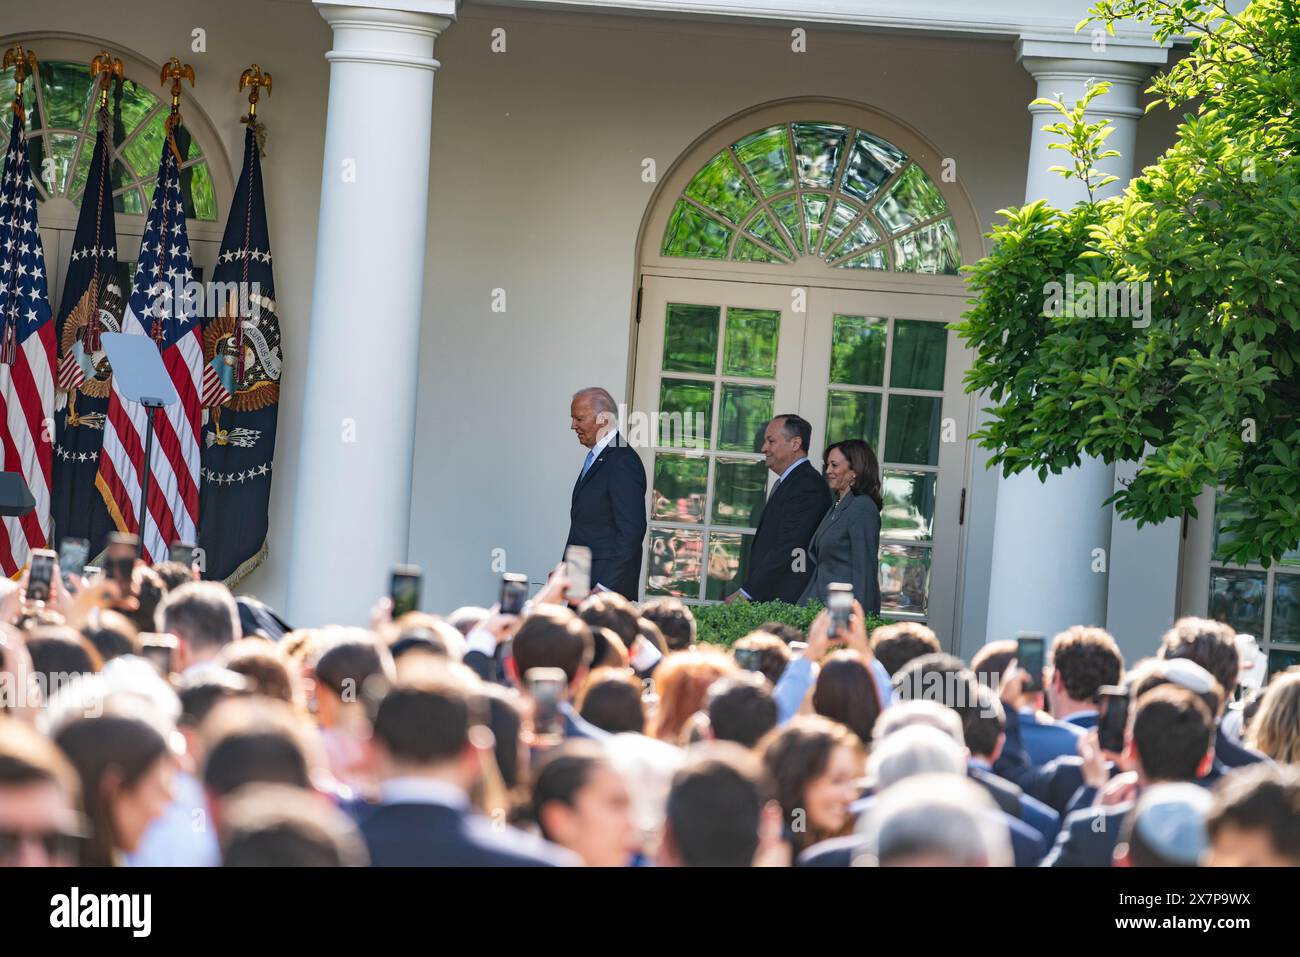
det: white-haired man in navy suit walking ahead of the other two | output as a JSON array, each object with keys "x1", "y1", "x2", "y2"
[{"x1": 566, "y1": 387, "x2": 646, "y2": 601}]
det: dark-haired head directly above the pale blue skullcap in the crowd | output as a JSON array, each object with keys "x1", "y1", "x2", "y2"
[{"x1": 1125, "y1": 685, "x2": 1214, "y2": 783}]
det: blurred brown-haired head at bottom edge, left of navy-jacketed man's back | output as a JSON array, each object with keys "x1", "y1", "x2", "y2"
[{"x1": 221, "y1": 784, "x2": 368, "y2": 867}]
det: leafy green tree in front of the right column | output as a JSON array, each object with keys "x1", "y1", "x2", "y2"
[{"x1": 956, "y1": 0, "x2": 1300, "y2": 567}]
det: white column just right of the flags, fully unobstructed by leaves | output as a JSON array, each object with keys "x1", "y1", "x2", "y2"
[{"x1": 287, "y1": 0, "x2": 456, "y2": 625}]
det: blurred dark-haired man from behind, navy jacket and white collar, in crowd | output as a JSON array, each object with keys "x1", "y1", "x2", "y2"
[{"x1": 358, "y1": 679, "x2": 576, "y2": 867}]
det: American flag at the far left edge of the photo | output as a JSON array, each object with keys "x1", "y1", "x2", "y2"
[{"x1": 0, "y1": 111, "x2": 55, "y2": 577}]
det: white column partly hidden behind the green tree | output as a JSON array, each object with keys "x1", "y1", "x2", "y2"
[{"x1": 985, "y1": 36, "x2": 1166, "y2": 641}]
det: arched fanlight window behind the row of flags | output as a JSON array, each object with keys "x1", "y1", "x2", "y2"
[{"x1": 0, "y1": 60, "x2": 217, "y2": 222}]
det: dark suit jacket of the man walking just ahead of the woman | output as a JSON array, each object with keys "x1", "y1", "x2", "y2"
[{"x1": 741, "y1": 462, "x2": 831, "y2": 605}]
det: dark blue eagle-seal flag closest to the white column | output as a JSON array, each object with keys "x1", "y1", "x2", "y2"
[{"x1": 199, "y1": 121, "x2": 281, "y2": 585}]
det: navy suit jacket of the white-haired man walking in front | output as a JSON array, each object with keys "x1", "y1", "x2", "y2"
[{"x1": 566, "y1": 433, "x2": 646, "y2": 601}]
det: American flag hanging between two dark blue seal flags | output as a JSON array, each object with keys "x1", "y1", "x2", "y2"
[{"x1": 95, "y1": 123, "x2": 203, "y2": 562}]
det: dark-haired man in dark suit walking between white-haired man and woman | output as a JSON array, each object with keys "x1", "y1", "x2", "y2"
[{"x1": 727, "y1": 415, "x2": 831, "y2": 605}]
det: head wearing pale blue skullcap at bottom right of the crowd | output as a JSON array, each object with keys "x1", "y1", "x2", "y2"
[{"x1": 1114, "y1": 781, "x2": 1213, "y2": 867}]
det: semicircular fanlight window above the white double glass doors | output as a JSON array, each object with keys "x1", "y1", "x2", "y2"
[{"x1": 662, "y1": 122, "x2": 961, "y2": 274}]
